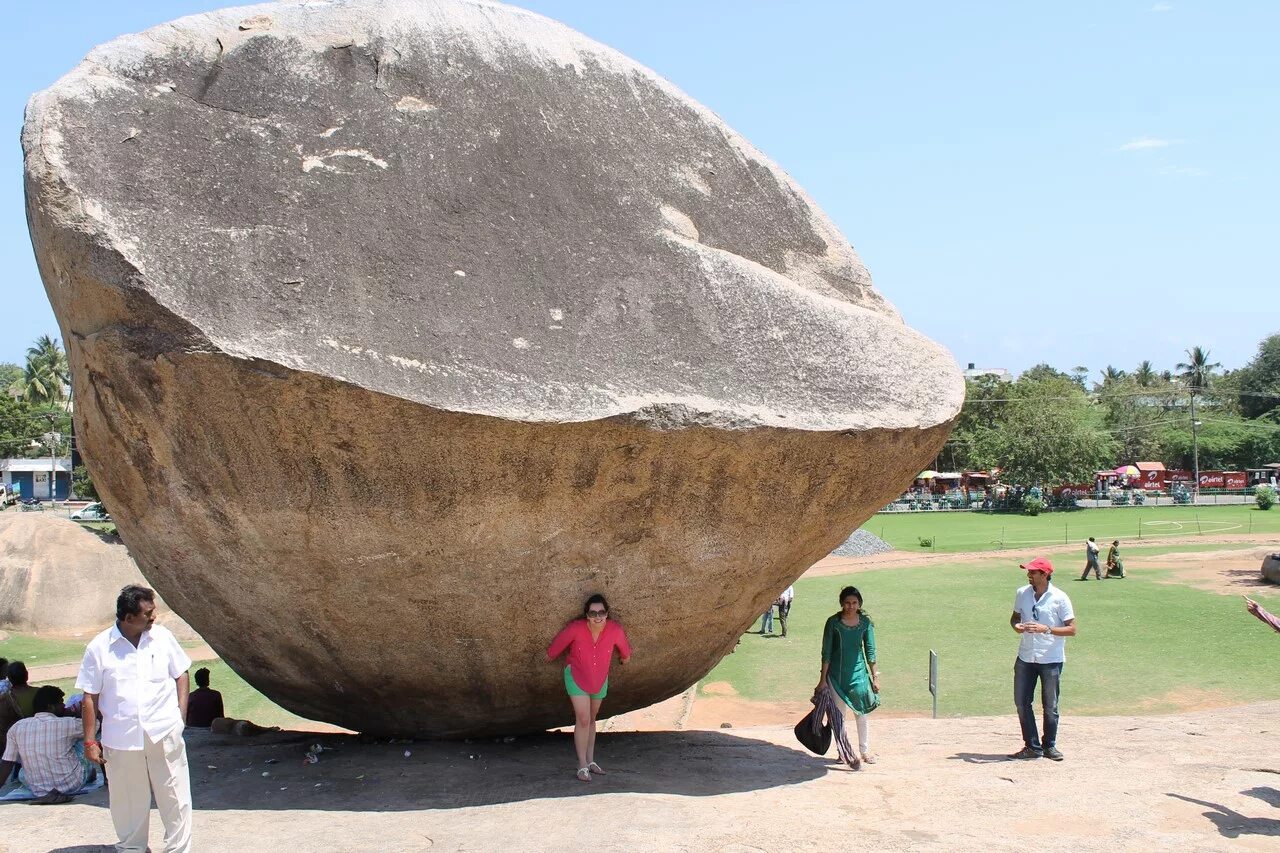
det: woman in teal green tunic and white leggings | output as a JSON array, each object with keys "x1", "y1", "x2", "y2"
[{"x1": 818, "y1": 587, "x2": 879, "y2": 765}]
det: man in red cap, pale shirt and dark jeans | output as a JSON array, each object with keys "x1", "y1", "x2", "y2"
[{"x1": 1009, "y1": 557, "x2": 1075, "y2": 761}]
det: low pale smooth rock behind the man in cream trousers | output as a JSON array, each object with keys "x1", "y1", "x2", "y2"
[{"x1": 0, "y1": 510, "x2": 193, "y2": 639}]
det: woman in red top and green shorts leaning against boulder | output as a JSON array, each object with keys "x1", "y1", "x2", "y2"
[{"x1": 547, "y1": 594, "x2": 631, "y2": 781}]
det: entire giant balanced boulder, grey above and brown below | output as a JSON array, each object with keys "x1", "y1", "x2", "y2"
[{"x1": 23, "y1": 1, "x2": 964, "y2": 735}]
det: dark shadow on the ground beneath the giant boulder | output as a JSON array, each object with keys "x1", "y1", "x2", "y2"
[{"x1": 57, "y1": 730, "x2": 835, "y2": 809}]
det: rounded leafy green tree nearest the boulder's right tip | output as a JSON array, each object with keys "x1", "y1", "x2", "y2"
[{"x1": 970, "y1": 369, "x2": 1115, "y2": 485}]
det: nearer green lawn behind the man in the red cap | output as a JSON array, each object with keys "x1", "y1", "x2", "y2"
[{"x1": 703, "y1": 555, "x2": 1280, "y2": 716}]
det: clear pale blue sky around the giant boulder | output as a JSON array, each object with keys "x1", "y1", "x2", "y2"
[{"x1": 0, "y1": 0, "x2": 1280, "y2": 379}]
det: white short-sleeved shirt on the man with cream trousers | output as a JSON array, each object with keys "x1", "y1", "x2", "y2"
[{"x1": 76, "y1": 625, "x2": 191, "y2": 751}]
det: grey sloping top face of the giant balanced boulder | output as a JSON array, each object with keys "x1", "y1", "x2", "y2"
[{"x1": 23, "y1": 0, "x2": 964, "y2": 430}]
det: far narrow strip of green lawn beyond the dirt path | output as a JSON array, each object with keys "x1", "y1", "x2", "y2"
[{"x1": 863, "y1": 506, "x2": 1280, "y2": 553}]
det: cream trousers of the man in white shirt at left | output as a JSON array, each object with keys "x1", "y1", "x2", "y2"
[{"x1": 104, "y1": 725, "x2": 191, "y2": 853}]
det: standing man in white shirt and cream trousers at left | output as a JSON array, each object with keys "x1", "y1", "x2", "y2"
[{"x1": 76, "y1": 584, "x2": 191, "y2": 853}]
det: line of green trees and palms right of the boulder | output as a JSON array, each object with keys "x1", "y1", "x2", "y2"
[{"x1": 937, "y1": 334, "x2": 1280, "y2": 487}]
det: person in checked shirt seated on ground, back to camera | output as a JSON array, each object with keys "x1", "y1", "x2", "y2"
[{"x1": 0, "y1": 684, "x2": 95, "y2": 802}]
